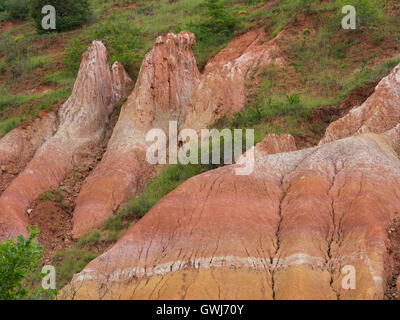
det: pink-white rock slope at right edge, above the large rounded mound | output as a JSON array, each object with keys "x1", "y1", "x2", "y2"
[{"x1": 321, "y1": 65, "x2": 400, "y2": 144}]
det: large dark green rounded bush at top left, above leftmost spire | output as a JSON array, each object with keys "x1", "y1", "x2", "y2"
[{"x1": 31, "y1": 0, "x2": 91, "y2": 33}]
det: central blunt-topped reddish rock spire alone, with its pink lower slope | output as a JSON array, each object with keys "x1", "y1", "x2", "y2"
[{"x1": 73, "y1": 31, "x2": 200, "y2": 238}]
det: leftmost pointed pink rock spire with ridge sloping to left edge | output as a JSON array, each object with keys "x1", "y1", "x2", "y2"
[{"x1": 0, "y1": 41, "x2": 132, "y2": 238}]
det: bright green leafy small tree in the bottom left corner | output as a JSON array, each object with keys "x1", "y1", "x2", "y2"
[{"x1": 0, "y1": 227, "x2": 52, "y2": 300}]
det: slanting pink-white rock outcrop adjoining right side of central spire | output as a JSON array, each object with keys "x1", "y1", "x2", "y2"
[{"x1": 184, "y1": 30, "x2": 284, "y2": 130}]
